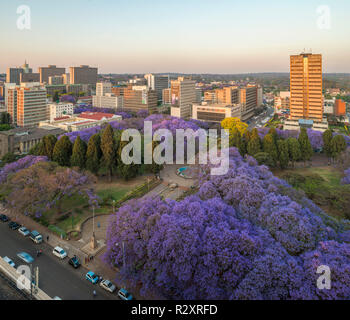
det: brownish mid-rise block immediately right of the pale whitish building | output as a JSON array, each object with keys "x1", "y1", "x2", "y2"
[{"x1": 123, "y1": 86, "x2": 158, "y2": 113}]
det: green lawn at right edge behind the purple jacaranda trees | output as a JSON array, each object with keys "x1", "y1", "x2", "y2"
[{"x1": 277, "y1": 167, "x2": 350, "y2": 219}]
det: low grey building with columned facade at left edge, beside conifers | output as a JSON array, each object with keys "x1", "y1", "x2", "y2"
[{"x1": 0, "y1": 126, "x2": 65, "y2": 158}]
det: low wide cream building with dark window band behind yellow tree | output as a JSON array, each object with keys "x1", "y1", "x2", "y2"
[{"x1": 192, "y1": 102, "x2": 241, "y2": 123}]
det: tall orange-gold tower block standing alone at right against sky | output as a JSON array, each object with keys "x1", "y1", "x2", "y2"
[{"x1": 290, "y1": 53, "x2": 323, "y2": 122}]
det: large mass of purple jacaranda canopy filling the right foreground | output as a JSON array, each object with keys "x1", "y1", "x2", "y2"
[{"x1": 104, "y1": 148, "x2": 350, "y2": 299}]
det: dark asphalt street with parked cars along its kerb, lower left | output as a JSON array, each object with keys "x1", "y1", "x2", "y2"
[{"x1": 0, "y1": 222, "x2": 118, "y2": 300}]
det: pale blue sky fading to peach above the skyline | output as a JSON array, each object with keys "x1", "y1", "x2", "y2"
[{"x1": 0, "y1": 0, "x2": 350, "y2": 74}]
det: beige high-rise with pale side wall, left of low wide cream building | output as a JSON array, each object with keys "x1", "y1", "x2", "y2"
[{"x1": 171, "y1": 77, "x2": 196, "y2": 119}]
